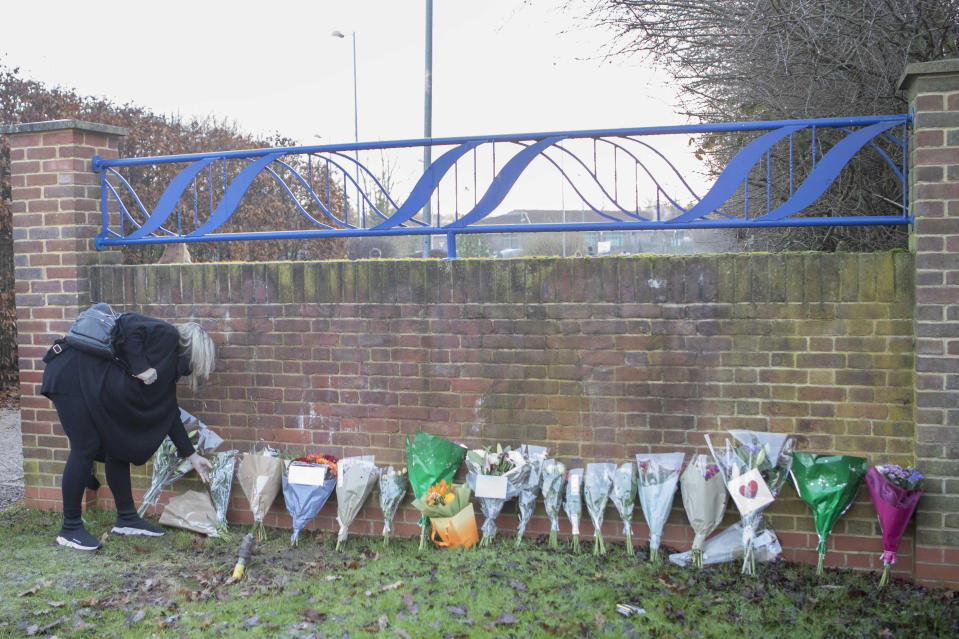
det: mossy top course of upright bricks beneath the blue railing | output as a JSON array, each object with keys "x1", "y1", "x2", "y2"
[{"x1": 90, "y1": 251, "x2": 913, "y2": 306}]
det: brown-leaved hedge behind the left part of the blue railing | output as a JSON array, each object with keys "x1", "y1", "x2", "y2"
[{"x1": 0, "y1": 64, "x2": 346, "y2": 263}]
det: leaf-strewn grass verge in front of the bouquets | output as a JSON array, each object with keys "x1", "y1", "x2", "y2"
[{"x1": 0, "y1": 506, "x2": 959, "y2": 639}]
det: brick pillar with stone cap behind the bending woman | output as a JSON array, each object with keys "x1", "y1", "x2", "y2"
[{"x1": 0, "y1": 120, "x2": 126, "y2": 509}]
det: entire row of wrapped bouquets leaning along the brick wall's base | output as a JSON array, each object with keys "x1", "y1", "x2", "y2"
[{"x1": 141, "y1": 420, "x2": 922, "y2": 582}]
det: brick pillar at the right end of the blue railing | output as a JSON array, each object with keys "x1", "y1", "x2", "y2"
[{"x1": 900, "y1": 59, "x2": 959, "y2": 587}]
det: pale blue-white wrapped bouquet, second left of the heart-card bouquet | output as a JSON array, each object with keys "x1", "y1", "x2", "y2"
[{"x1": 636, "y1": 453, "x2": 686, "y2": 565}]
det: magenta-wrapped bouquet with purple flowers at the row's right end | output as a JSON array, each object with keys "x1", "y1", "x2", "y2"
[{"x1": 866, "y1": 464, "x2": 923, "y2": 587}]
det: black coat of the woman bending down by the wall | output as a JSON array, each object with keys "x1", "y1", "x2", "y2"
[{"x1": 40, "y1": 313, "x2": 195, "y2": 464}]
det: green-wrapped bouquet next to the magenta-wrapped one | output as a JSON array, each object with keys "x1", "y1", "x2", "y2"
[{"x1": 790, "y1": 453, "x2": 866, "y2": 575}]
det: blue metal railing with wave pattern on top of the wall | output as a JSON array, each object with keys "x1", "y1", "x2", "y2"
[{"x1": 93, "y1": 115, "x2": 912, "y2": 257}]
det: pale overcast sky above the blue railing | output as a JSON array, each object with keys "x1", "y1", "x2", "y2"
[{"x1": 0, "y1": 0, "x2": 694, "y2": 211}]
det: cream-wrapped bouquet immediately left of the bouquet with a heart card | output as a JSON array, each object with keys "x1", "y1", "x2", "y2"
[{"x1": 679, "y1": 455, "x2": 726, "y2": 568}]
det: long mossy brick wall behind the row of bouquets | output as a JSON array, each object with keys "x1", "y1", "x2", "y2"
[{"x1": 65, "y1": 253, "x2": 915, "y2": 574}]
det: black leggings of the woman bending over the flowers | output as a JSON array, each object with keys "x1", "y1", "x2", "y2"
[{"x1": 50, "y1": 393, "x2": 136, "y2": 527}]
